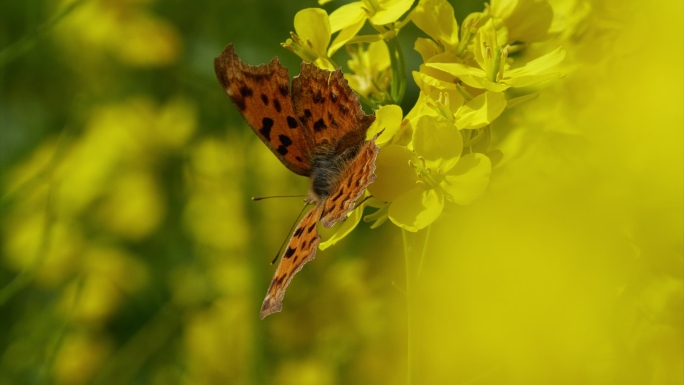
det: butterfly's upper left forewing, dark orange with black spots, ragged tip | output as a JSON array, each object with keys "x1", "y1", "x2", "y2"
[{"x1": 214, "y1": 44, "x2": 314, "y2": 176}]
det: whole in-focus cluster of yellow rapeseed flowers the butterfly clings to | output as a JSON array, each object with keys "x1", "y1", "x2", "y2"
[{"x1": 283, "y1": 0, "x2": 565, "y2": 240}]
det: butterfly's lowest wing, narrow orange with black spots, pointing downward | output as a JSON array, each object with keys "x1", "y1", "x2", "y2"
[{"x1": 259, "y1": 204, "x2": 322, "y2": 319}]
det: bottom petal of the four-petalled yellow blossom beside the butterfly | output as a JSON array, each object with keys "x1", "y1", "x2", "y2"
[{"x1": 389, "y1": 186, "x2": 444, "y2": 232}]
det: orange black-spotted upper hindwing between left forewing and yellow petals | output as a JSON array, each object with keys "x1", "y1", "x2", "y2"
[{"x1": 292, "y1": 63, "x2": 375, "y2": 153}]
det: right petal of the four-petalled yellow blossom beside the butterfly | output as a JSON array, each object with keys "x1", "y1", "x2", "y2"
[{"x1": 440, "y1": 153, "x2": 492, "y2": 205}]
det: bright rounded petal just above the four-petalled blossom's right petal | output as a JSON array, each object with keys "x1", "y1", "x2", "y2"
[{"x1": 456, "y1": 91, "x2": 506, "y2": 130}]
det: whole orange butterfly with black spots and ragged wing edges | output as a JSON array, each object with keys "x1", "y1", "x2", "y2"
[{"x1": 214, "y1": 44, "x2": 379, "y2": 319}]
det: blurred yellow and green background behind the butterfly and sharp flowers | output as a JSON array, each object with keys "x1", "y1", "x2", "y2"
[{"x1": 0, "y1": 0, "x2": 684, "y2": 385}]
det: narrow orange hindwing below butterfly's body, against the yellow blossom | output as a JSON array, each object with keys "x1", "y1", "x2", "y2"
[{"x1": 320, "y1": 135, "x2": 380, "y2": 227}]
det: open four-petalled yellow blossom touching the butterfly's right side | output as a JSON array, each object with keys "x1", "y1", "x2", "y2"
[{"x1": 368, "y1": 115, "x2": 491, "y2": 231}]
